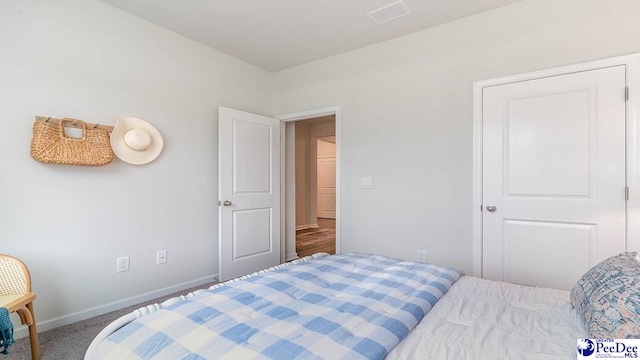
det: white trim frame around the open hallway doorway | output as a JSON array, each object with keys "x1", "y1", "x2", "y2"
[{"x1": 274, "y1": 105, "x2": 341, "y2": 262}]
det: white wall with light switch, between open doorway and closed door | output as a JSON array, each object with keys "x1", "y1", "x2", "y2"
[{"x1": 273, "y1": 0, "x2": 640, "y2": 273}]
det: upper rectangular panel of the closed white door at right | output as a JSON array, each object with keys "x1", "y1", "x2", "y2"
[{"x1": 504, "y1": 89, "x2": 595, "y2": 197}]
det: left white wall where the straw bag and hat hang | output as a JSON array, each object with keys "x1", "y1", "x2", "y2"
[{"x1": 0, "y1": 0, "x2": 271, "y2": 331}]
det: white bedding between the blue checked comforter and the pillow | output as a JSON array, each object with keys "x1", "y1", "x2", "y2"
[{"x1": 386, "y1": 276, "x2": 588, "y2": 360}]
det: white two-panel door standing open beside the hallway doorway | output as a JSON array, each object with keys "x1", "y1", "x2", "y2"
[{"x1": 218, "y1": 107, "x2": 280, "y2": 281}]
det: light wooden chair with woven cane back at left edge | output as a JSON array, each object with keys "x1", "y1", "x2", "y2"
[{"x1": 0, "y1": 254, "x2": 40, "y2": 360}]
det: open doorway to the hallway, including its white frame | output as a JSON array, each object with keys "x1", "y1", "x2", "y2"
[{"x1": 276, "y1": 106, "x2": 341, "y2": 261}]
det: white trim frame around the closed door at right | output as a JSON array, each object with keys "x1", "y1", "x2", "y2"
[{"x1": 472, "y1": 53, "x2": 640, "y2": 277}]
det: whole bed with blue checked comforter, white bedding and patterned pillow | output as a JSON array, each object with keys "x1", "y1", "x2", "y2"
[{"x1": 85, "y1": 253, "x2": 640, "y2": 359}]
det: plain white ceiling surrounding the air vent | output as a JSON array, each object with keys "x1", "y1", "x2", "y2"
[{"x1": 100, "y1": 0, "x2": 522, "y2": 72}]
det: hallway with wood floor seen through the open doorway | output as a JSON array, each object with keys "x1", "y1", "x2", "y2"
[{"x1": 295, "y1": 115, "x2": 336, "y2": 257}]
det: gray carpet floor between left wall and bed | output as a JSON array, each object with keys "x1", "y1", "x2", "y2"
[{"x1": 0, "y1": 283, "x2": 220, "y2": 360}]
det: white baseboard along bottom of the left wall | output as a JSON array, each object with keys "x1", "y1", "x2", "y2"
[{"x1": 13, "y1": 274, "x2": 218, "y2": 339}]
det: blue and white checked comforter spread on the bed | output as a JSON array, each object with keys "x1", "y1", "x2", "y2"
[{"x1": 94, "y1": 254, "x2": 462, "y2": 360}]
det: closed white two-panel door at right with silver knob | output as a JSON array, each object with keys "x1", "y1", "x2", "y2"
[{"x1": 482, "y1": 66, "x2": 625, "y2": 290}]
